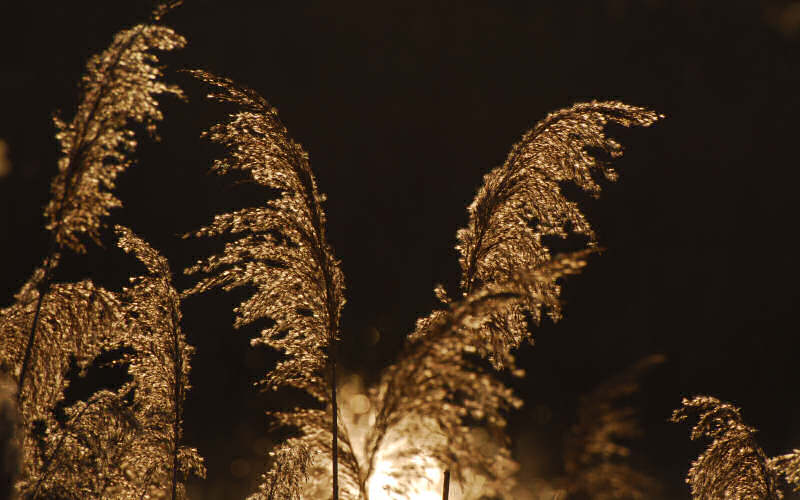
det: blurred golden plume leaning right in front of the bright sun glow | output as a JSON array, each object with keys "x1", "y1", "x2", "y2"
[{"x1": 344, "y1": 254, "x2": 585, "y2": 499}]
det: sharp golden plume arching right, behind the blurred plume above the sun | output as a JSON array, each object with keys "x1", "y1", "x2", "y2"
[{"x1": 456, "y1": 101, "x2": 660, "y2": 367}]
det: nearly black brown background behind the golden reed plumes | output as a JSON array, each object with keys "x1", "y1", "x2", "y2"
[{"x1": 0, "y1": 0, "x2": 800, "y2": 499}]
